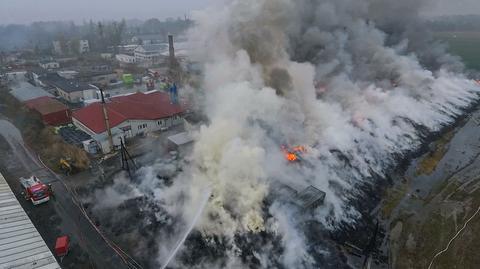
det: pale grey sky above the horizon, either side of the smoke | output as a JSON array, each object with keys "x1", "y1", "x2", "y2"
[{"x1": 0, "y1": 0, "x2": 480, "y2": 24}]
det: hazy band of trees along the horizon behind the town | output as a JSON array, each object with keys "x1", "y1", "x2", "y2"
[{"x1": 0, "y1": 18, "x2": 193, "y2": 53}]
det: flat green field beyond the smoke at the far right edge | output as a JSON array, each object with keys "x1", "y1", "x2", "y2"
[{"x1": 435, "y1": 32, "x2": 480, "y2": 71}]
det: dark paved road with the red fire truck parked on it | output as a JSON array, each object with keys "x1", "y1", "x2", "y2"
[{"x1": 0, "y1": 119, "x2": 128, "y2": 269}]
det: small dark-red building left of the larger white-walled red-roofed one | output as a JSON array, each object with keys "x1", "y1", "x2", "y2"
[{"x1": 25, "y1": 96, "x2": 72, "y2": 126}]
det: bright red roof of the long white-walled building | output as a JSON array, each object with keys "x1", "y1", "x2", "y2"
[{"x1": 73, "y1": 92, "x2": 184, "y2": 134}]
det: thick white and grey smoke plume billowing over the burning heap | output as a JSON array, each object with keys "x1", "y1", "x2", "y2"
[{"x1": 156, "y1": 0, "x2": 479, "y2": 268}]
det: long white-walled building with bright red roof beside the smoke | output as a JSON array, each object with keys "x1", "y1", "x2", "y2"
[{"x1": 72, "y1": 91, "x2": 185, "y2": 153}]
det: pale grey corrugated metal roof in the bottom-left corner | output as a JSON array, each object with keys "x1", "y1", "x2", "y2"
[{"x1": 0, "y1": 174, "x2": 60, "y2": 269}]
